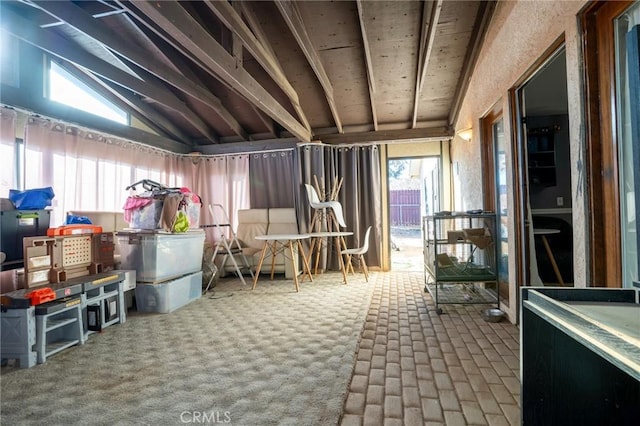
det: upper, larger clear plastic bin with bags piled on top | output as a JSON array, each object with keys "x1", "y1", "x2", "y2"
[{"x1": 117, "y1": 230, "x2": 204, "y2": 283}]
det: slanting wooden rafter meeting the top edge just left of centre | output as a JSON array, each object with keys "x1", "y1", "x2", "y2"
[{"x1": 275, "y1": 0, "x2": 343, "y2": 133}]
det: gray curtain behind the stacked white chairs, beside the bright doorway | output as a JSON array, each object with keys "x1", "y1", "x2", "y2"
[{"x1": 296, "y1": 145, "x2": 382, "y2": 269}]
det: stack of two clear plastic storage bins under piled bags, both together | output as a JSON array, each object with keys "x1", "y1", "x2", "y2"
[{"x1": 117, "y1": 229, "x2": 205, "y2": 313}]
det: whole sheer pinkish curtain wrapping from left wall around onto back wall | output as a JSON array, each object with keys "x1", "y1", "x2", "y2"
[{"x1": 20, "y1": 117, "x2": 250, "y2": 233}]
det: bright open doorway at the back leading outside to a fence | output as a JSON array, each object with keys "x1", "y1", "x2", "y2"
[{"x1": 388, "y1": 157, "x2": 441, "y2": 272}]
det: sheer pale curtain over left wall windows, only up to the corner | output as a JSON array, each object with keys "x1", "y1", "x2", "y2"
[{"x1": 25, "y1": 117, "x2": 190, "y2": 226}]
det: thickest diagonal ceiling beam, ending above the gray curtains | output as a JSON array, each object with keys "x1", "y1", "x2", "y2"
[{"x1": 127, "y1": 1, "x2": 311, "y2": 141}]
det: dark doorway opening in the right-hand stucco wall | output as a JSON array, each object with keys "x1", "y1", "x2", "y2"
[{"x1": 516, "y1": 46, "x2": 573, "y2": 286}]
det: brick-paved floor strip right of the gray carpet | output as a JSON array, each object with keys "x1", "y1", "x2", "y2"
[{"x1": 340, "y1": 272, "x2": 520, "y2": 426}]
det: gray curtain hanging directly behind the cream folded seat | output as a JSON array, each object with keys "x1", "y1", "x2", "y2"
[{"x1": 249, "y1": 149, "x2": 298, "y2": 209}]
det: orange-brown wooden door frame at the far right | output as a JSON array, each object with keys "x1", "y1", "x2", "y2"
[{"x1": 580, "y1": 1, "x2": 634, "y2": 287}]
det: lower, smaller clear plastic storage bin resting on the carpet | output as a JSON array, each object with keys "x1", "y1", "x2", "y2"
[{"x1": 136, "y1": 271, "x2": 202, "y2": 314}]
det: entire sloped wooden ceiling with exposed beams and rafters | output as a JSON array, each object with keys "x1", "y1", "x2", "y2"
[{"x1": 0, "y1": 0, "x2": 494, "y2": 152}]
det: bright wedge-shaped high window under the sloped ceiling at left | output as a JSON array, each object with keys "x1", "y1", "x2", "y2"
[{"x1": 49, "y1": 62, "x2": 129, "y2": 125}]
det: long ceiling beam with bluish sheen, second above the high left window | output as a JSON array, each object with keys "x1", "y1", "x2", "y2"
[{"x1": 33, "y1": 0, "x2": 248, "y2": 138}]
